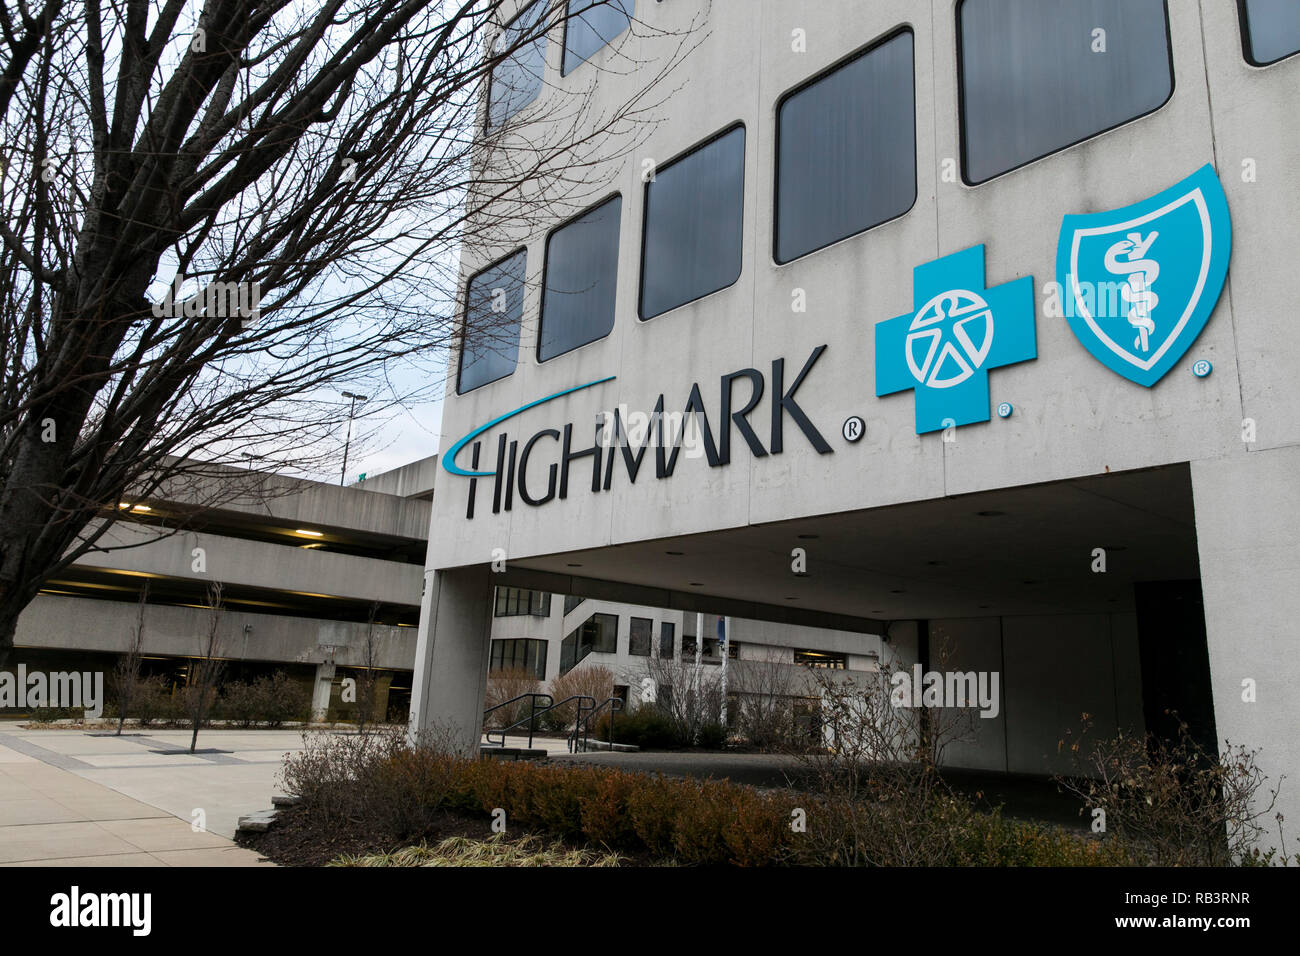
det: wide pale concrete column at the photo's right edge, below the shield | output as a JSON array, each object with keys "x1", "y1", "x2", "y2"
[{"x1": 1192, "y1": 446, "x2": 1300, "y2": 852}]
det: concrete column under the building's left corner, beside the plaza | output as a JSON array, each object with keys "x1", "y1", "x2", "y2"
[{"x1": 411, "y1": 564, "x2": 493, "y2": 752}]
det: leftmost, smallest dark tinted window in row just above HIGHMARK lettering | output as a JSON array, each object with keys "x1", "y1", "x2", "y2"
[{"x1": 459, "y1": 250, "x2": 528, "y2": 393}]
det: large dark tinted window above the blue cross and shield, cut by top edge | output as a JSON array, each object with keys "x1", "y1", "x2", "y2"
[{"x1": 958, "y1": 0, "x2": 1174, "y2": 183}]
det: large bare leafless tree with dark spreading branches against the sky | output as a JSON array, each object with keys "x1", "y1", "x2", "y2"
[{"x1": 0, "y1": 0, "x2": 707, "y2": 662}]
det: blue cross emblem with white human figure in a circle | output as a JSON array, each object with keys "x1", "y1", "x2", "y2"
[{"x1": 876, "y1": 245, "x2": 1039, "y2": 434}]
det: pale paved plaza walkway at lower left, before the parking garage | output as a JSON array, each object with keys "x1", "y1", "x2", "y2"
[{"x1": 0, "y1": 723, "x2": 319, "y2": 866}]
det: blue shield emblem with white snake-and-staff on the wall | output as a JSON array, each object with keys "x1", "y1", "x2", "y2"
[{"x1": 1057, "y1": 164, "x2": 1232, "y2": 388}]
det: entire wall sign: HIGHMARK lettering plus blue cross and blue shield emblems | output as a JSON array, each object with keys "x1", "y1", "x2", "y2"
[{"x1": 442, "y1": 165, "x2": 1232, "y2": 519}]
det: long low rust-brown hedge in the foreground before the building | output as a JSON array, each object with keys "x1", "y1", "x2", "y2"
[{"x1": 282, "y1": 731, "x2": 1274, "y2": 866}]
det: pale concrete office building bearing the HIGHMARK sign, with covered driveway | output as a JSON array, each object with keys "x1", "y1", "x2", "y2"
[{"x1": 413, "y1": 0, "x2": 1300, "y2": 837}]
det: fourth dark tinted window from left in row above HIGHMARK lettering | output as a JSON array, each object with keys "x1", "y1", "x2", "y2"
[{"x1": 776, "y1": 31, "x2": 917, "y2": 263}]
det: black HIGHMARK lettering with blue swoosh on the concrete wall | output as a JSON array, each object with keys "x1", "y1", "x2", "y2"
[{"x1": 442, "y1": 345, "x2": 832, "y2": 519}]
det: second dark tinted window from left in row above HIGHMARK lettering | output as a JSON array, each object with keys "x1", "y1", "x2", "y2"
[{"x1": 537, "y1": 196, "x2": 623, "y2": 362}]
